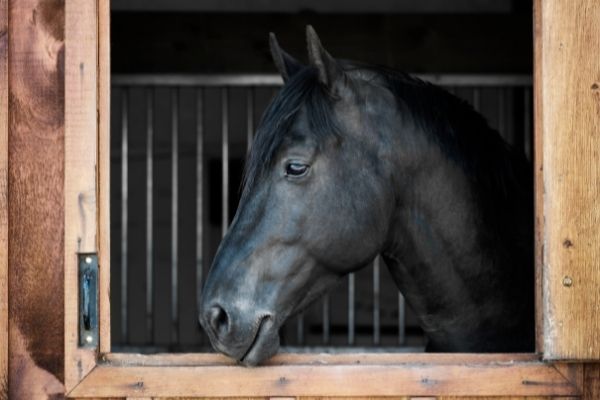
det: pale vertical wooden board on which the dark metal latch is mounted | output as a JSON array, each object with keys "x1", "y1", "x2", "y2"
[{"x1": 64, "y1": 0, "x2": 98, "y2": 391}]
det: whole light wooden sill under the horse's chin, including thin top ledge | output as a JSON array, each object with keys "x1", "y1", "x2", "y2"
[{"x1": 69, "y1": 353, "x2": 580, "y2": 398}]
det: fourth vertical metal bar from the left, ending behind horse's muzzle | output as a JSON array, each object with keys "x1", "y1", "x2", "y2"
[{"x1": 196, "y1": 88, "x2": 204, "y2": 338}]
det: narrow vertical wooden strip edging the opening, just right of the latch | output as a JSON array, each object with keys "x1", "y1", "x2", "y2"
[{"x1": 97, "y1": 1, "x2": 110, "y2": 353}]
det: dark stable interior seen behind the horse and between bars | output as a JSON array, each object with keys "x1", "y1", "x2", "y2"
[{"x1": 111, "y1": 1, "x2": 533, "y2": 352}]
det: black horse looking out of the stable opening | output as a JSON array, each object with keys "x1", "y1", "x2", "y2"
[{"x1": 200, "y1": 27, "x2": 534, "y2": 365}]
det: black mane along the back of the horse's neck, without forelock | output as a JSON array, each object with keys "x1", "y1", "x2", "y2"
[{"x1": 370, "y1": 67, "x2": 533, "y2": 253}]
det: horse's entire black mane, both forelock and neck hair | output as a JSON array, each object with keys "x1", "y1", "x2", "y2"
[{"x1": 244, "y1": 62, "x2": 532, "y2": 253}]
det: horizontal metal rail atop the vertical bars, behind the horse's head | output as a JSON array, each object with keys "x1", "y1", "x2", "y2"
[{"x1": 111, "y1": 74, "x2": 533, "y2": 87}]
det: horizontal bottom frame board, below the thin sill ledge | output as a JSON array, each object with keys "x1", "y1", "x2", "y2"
[{"x1": 70, "y1": 362, "x2": 578, "y2": 397}]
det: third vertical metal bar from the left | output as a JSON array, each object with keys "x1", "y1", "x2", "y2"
[{"x1": 171, "y1": 88, "x2": 179, "y2": 343}]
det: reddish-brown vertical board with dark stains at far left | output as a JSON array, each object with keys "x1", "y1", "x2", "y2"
[{"x1": 8, "y1": 0, "x2": 64, "y2": 399}]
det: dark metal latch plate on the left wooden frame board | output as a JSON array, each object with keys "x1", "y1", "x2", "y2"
[{"x1": 78, "y1": 253, "x2": 98, "y2": 347}]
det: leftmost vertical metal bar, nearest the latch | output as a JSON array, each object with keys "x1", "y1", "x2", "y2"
[{"x1": 121, "y1": 89, "x2": 129, "y2": 343}]
